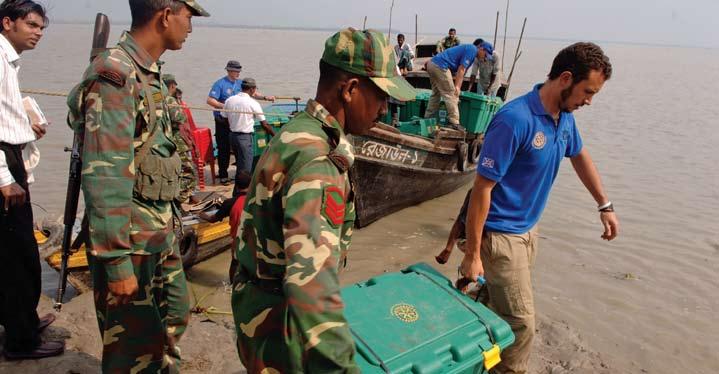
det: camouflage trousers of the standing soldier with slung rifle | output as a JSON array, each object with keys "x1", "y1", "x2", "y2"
[{"x1": 88, "y1": 248, "x2": 190, "y2": 373}]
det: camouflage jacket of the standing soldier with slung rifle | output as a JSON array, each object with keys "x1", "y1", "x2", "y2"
[{"x1": 67, "y1": 32, "x2": 176, "y2": 281}]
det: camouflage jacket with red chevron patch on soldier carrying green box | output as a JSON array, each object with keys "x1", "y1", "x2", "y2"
[{"x1": 236, "y1": 100, "x2": 357, "y2": 372}]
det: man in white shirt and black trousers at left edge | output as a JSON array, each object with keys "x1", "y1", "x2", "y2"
[{"x1": 0, "y1": 0, "x2": 65, "y2": 359}]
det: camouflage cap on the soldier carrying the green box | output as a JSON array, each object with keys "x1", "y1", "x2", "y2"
[{"x1": 322, "y1": 27, "x2": 417, "y2": 101}]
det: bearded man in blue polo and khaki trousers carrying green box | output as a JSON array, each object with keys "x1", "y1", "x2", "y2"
[{"x1": 460, "y1": 43, "x2": 619, "y2": 373}]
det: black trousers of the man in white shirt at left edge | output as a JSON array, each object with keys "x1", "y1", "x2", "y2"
[{"x1": 0, "y1": 143, "x2": 41, "y2": 352}]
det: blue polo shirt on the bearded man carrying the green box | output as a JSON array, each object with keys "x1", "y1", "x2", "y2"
[{"x1": 477, "y1": 84, "x2": 582, "y2": 234}]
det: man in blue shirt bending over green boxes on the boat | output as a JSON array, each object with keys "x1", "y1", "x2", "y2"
[{"x1": 424, "y1": 39, "x2": 482, "y2": 129}]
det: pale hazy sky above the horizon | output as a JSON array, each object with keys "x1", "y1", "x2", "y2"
[{"x1": 40, "y1": 0, "x2": 719, "y2": 48}]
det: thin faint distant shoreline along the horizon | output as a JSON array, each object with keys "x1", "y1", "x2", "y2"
[{"x1": 53, "y1": 21, "x2": 719, "y2": 50}]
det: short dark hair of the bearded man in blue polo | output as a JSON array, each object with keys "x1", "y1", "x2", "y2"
[{"x1": 548, "y1": 42, "x2": 612, "y2": 83}]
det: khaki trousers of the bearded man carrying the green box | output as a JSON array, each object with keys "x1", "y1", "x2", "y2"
[{"x1": 480, "y1": 227, "x2": 539, "y2": 374}]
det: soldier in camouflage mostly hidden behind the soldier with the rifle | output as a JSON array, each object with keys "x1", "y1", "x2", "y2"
[{"x1": 162, "y1": 74, "x2": 197, "y2": 204}]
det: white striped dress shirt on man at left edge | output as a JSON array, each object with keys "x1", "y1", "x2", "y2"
[{"x1": 0, "y1": 34, "x2": 35, "y2": 187}]
